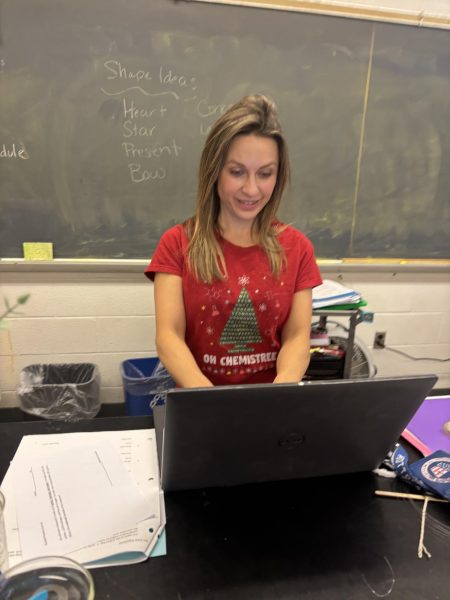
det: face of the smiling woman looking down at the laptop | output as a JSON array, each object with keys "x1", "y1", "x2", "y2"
[{"x1": 217, "y1": 134, "x2": 278, "y2": 227}]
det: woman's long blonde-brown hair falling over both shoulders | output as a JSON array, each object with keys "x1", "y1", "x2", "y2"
[{"x1": 185, "y1": 95, "x2": 290, "y2": 283}]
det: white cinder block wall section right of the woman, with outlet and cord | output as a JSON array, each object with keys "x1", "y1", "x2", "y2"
[{"x1": 323, "y1": 271, "x2": 450, "y2": 388}]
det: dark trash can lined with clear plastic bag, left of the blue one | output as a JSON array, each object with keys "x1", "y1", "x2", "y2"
[{"x1": 17, "y1": 363, "x2": 100, "y2": 422}]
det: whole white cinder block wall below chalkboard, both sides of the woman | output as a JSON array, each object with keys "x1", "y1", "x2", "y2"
[{"x1": 0, "y1": 266, "x2": 450, "y2": 407}]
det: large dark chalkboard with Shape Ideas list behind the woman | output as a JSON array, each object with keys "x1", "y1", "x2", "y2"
[{"x1": 0, "y1": 0, "x2": 450, "y2": 259}]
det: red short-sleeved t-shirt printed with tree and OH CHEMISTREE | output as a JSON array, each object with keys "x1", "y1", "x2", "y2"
[{"x1": 145, "y1": 225, "x2": 322, "y2": 385}]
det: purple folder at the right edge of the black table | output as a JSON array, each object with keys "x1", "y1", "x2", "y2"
[{"x1": 402, "y1": 396, "x2": 450, "y2": 456}]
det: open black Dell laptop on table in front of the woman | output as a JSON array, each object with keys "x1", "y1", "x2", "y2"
[{"x1": 154, "y1": 375, "x2": 437, "y2": 491}]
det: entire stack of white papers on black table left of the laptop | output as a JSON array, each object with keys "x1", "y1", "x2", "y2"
[{"x1": 2, "y1": 429, "x2": 166, "y2": 567}]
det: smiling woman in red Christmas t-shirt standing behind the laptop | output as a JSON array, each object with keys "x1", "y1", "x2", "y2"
[{"x1": 146, "y1": 95, "x2": 322, "y2": 387}]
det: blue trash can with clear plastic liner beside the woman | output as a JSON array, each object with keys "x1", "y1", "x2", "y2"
[{"x1": 120, "y1": 357, "x2": 175, "y2": 416}]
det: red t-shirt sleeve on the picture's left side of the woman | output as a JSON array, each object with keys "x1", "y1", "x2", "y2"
[{"x1": 145, "y1": 225, "x2": 185, "y2": 281}]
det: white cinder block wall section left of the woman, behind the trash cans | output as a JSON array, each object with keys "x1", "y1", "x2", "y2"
[{"x1": 0, "y1": 272, "x2": 155, "y2": 407}]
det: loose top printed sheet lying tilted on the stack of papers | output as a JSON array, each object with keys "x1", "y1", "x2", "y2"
[{"x1": 13, "y1": 442, "x2": 149, "y2": 559}]
